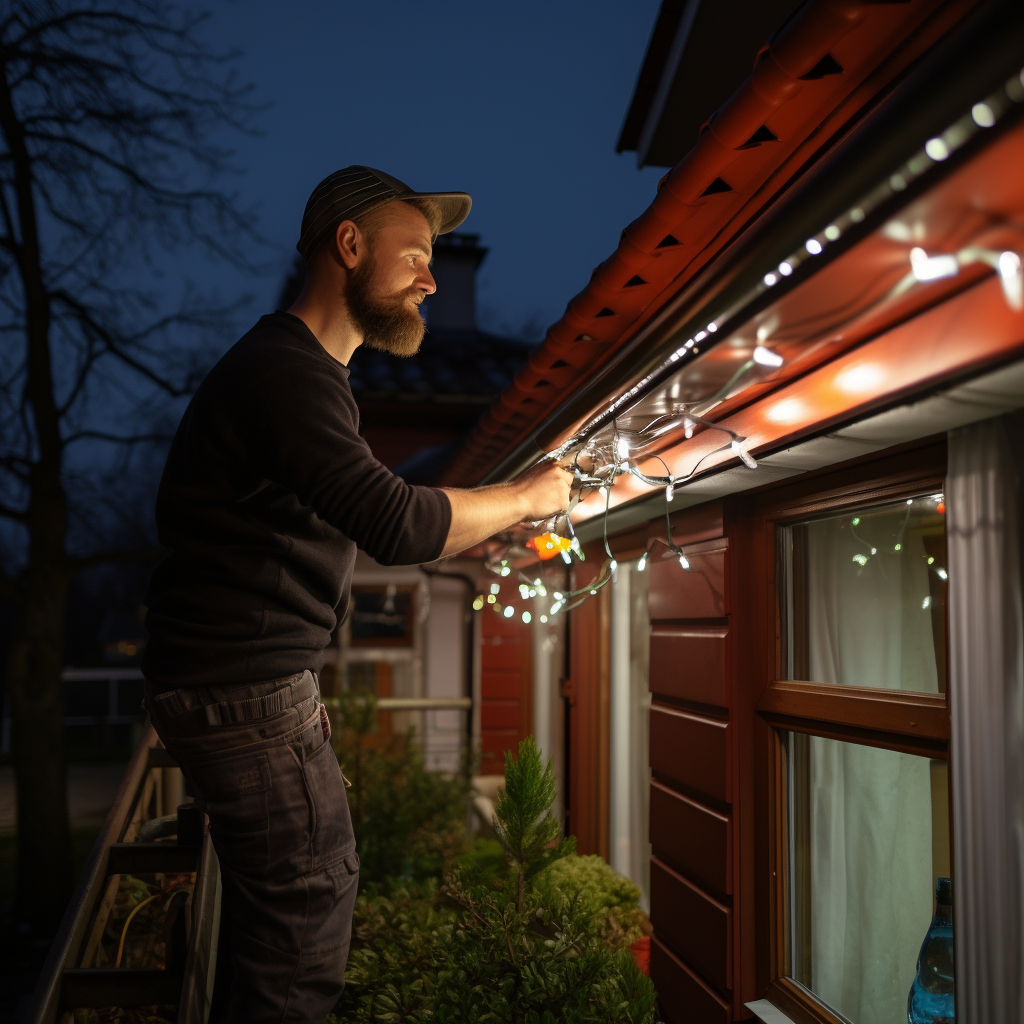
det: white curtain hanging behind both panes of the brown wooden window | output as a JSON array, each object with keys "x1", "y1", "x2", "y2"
[{"x1": 807, "y1": 519, "x2": 938, "y2": 1024}]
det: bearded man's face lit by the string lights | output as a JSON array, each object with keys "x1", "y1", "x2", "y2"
[{"x1": 345, "y1": 203, "x2": 436, "y2": 355}]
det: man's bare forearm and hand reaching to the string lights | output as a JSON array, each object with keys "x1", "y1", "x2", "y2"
[{"x1": 441, "y1": 462, "x2": 572, "y2": 558}]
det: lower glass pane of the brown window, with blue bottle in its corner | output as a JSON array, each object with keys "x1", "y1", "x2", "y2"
[{"x1": 787, "y1": 733, "x2": 952, "y2": 1024}]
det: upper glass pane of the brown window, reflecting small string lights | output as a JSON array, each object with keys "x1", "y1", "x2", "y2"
[{"x1": 780, "y1": 495, "x2": 947, "y2": 693}]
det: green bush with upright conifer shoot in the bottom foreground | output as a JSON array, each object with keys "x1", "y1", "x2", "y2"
[{"x1": 333, "y1": 738, "x2": 657, "y2": 1024}]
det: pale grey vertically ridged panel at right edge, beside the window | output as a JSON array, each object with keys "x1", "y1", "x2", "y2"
[{"x1": 946, "y1": 414, "x2": 1024, "y2": 1024}]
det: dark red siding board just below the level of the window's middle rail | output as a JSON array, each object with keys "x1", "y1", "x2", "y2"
[{"x1": 650, "y1": 705, "x2": 732, "y2": 802}]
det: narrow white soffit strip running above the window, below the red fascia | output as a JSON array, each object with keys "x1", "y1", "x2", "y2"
[{"x1": 575, "y1": 359, "x2": 1024, "y2": 541}]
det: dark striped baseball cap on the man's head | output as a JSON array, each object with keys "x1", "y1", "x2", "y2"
[{"x1": 295, "y1": 164, "x2": 473, "y2": 259}]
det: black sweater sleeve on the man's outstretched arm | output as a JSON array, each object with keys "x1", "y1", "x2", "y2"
[{"x1": 240, "y1": 344, "x2": 452, "y2": 565}]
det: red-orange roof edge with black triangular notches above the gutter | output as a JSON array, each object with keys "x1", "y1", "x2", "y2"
[{"x1": 442, "y1": 0, "x2": 978, "y2": 486}]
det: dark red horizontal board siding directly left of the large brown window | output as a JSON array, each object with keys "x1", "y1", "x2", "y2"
[{"x1": 648, "y1": 503, "x2": 745, "y2": 1024}]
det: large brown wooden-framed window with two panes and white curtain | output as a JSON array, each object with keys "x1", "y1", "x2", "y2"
[{"x1": 751, "y1": 444, "x2": 955, "y2": 1024}]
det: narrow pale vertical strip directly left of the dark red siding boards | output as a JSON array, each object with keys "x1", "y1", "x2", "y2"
[{"x1": 608, "y1": 563, "x2": 650, "y2": 911}]
